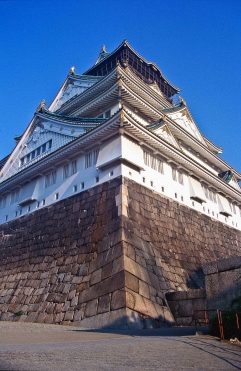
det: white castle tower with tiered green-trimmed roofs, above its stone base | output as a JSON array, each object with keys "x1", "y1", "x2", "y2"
[{"x1": 0, "y1": 40, "x2": 241, "y2": 230}]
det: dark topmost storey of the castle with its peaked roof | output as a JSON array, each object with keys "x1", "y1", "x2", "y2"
[{"x1": 84, "y1": 40, "x2": 180, "y2": 98}]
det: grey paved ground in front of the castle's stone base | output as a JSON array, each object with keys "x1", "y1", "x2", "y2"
[{"x1": 0, "y1": 322, "x2": 241, "y2": 371}]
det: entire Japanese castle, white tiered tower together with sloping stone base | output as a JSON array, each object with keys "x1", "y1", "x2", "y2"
[{"x1": 0, "y1": 40, "x2": 241, "y2": 329}]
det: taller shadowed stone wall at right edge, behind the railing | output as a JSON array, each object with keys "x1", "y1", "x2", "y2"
[{"x1": 203, "y1": 256, "x2": 241, "y2": 310}]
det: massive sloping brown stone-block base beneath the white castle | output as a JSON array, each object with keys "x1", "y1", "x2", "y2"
[{"x1": 0, "y1": 177, "x2": 241, "y2": 328}]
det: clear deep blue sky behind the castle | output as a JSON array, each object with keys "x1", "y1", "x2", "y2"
[{"x1": 0, "y1": 0, "x2": 241, "y2": 171}]
